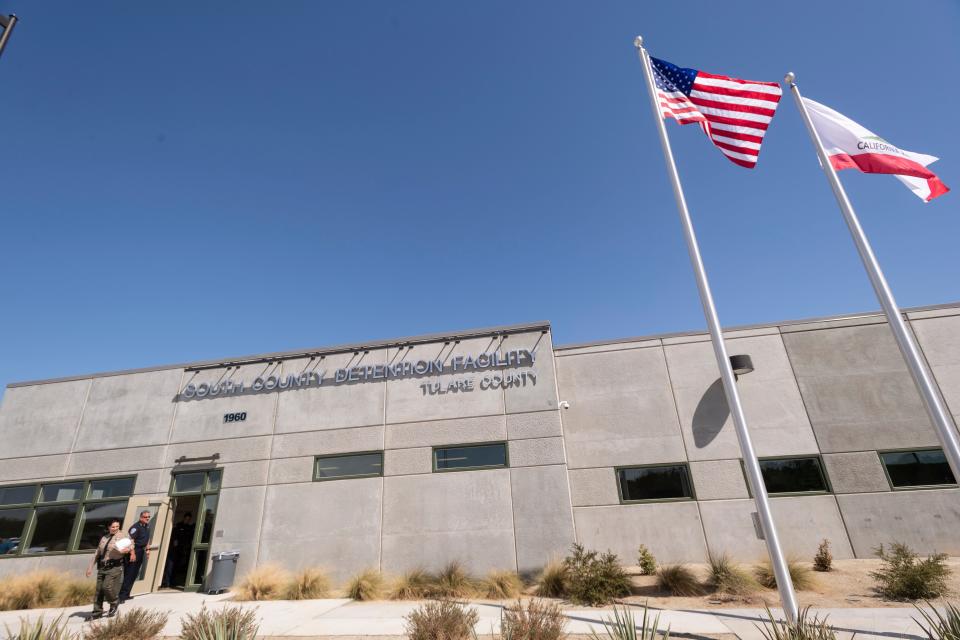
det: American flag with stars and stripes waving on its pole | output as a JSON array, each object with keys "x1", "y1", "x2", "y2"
[{"x1": 650, "y1": 57, "x2": 783, "y2": 169}]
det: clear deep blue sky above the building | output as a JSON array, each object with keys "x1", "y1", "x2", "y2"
[{"x1": 0, "y1": 0, "x2": 960, "y2": 386}]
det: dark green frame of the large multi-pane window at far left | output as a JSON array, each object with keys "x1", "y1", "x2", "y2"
[{"x1": 0, "y1": 473, "x2": 137, "y2": 561}]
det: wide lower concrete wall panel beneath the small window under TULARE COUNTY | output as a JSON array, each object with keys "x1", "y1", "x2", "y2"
[{"x1": 383, "y1": 469, "x2": 517, "y2": 573}]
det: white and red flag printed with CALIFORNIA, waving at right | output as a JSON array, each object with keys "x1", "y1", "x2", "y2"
[{"x1": 803, "y1": 98, "x2": 950, "y2": 202}]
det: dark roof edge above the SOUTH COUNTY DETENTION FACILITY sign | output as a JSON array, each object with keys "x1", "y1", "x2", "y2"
[{"x1": 7, "y1": 320, "x2": 550, "y2": 389}]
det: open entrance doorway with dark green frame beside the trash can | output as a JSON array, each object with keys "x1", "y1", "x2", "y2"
[{"x1": 170, "y1": 469, "x2": 222, "y2": 591}]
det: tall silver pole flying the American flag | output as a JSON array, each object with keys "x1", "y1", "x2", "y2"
[{"x1": 634, "y1": 36, "x2": 797, "y2": 623}]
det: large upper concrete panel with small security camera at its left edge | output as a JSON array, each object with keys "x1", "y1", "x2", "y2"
[{"x1": 556, "y1": 349, "x2": 686, "y2": 468}]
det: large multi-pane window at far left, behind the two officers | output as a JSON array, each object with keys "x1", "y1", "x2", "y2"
[{"x1": 0, "y1": 477, "x2": 135, "y2": 557}]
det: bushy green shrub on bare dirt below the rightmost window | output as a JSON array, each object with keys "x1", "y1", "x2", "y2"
[{"x1": 870, "y1": 542, "x2": 950, "y2": 600}]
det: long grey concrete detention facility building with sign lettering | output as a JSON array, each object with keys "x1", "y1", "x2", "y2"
[{"x1": 0, "y1": 305, "x2": 960, "y2": 592}]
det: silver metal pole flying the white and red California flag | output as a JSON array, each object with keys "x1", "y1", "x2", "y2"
[{"x1": 784, "y1": 72, "x2": 960, "y2": 481}]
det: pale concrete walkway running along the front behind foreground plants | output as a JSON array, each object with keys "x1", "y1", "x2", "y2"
[{"x1": 0, "y1": 593, "x2": 925, "y2": 640}]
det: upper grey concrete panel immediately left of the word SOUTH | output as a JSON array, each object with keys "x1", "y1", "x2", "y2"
[{"x1": 75, "y1": 369, "x2": 183, "y2": 451}]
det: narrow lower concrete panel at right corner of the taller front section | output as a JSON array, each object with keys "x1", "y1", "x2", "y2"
[{"x1": 510, "y1": 465, "x2": 575, "y2": 572}]
